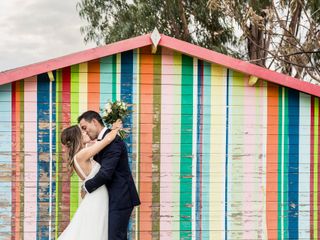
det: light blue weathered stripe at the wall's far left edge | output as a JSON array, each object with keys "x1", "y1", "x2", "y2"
[{"x1": 0, "y1": 84, "x2": 12, "y2": 235}]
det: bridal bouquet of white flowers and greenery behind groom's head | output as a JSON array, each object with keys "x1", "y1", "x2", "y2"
[{"x1": 102, "y1": 101, "x2": 131, "y2": 139}]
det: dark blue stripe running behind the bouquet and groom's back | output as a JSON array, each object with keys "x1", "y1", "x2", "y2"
[{"x1": 120, "y1": 51, "x2": 133, "y2": 240}]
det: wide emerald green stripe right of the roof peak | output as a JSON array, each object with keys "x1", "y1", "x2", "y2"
[{"x1": 180, "y1": 55, "x2": 193, "y2": 239}]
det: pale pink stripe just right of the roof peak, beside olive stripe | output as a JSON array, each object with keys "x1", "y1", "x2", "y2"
[{"x1": 160, "y1": 48, "x2": 174, "y2": 239}]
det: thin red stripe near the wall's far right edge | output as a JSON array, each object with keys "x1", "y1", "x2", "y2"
[{"x1": 310, "y1": 97, "x2": 314, "y2": 239}]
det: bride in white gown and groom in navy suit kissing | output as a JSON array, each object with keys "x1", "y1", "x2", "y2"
[{"x1": 58, "y1": 111, "x2": 140, "y2": 240}]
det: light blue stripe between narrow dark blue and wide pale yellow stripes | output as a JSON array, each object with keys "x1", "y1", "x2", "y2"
[{"x1": 201, "y1": 62, "x2": 211, "y2": 239}]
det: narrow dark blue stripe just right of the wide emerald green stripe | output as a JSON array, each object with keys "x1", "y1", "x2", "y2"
[{"x1": 196, "y1": 60, "x2": 203, "y2": 239}]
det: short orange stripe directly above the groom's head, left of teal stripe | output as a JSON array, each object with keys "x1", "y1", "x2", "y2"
[{"x1": 88, "y1": 59, "x2": 100, "y2": 112}]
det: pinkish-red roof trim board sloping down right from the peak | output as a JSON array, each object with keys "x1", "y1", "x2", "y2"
[{"x1": 159, "y1": 35, "x2": 320, "y2": 97}]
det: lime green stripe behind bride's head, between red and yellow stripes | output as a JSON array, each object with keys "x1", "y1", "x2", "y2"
[{"x1": 70, "y1": 65, "x2": 80, "y2": 219}]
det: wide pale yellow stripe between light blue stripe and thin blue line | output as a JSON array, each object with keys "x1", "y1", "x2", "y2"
[{"x1": 210, "y1": 64, "x2": 226, "y2": 239}]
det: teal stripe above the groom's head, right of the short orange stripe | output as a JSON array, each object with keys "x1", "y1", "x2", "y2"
[{"x1": 100, "y1": 55, "x2": 115, "y2": 109}]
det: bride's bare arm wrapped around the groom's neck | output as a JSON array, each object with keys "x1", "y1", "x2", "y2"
[{"x1": 76, "y1": 120, "x2": 122, "y2": 162}]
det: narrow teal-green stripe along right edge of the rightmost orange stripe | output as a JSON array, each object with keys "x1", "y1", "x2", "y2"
[{"x1": 278, "y1": 87, "x2": 283, "y2": 239}]
